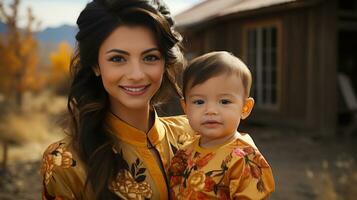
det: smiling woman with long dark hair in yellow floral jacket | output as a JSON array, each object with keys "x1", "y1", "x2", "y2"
[{"x1": 42, "y1": 0, "x2": 192, "y2": 199}]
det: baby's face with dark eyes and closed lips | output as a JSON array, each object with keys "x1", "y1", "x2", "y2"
[{"x1": 183, "y1": 74, "x2": 249, "y2": 144}]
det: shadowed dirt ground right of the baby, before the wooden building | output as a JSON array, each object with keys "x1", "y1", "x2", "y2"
[{"x1": 251, "y1": 128, "x2": 357, "y2": 200}]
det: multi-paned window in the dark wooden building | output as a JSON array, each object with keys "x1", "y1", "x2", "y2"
[{"x1": 244, "y1": 20, "x2": 281, "y2": 109}]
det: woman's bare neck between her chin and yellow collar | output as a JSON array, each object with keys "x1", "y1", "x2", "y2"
[{"x1": 111, "y1": 104, "x2": 153, "y2": 133}]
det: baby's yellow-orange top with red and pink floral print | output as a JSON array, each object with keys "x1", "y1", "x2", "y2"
[{"x1": 169, "y1": 134, "x2": 275, "y2": 200}]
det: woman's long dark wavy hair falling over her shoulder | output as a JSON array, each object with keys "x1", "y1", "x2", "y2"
[{"x1": 67, "y1": 0, "x2": 183, "y2": 199}]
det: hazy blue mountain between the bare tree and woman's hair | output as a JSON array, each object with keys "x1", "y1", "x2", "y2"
[{"x1": 35, "y1": 25, "x2": 77, "y2": 47}]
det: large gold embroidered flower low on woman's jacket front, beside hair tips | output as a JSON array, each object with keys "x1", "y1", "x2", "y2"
[{"x1": 109, "y1": 170, "x2": 152, "y2": 200}]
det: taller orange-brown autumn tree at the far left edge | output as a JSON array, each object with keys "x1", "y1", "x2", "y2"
[{"x1": 0, "y1": 0, "x2": 39, "y2": 108}]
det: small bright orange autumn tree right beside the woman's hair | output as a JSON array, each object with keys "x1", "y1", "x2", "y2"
[{"x1": 49, "y1": 42, "x2": 73, "y2": 94}]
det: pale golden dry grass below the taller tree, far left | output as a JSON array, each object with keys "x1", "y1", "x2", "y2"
[{"x1": 0, "y1": 92, "x2": 66, "y2": 162}]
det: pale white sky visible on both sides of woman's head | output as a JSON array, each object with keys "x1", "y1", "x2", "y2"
[{"x1": 4, "y1": 0, "x2": 202, "y2": 29}]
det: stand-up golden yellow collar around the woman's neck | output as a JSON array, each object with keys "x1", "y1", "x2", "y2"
[{"x1": 105, "y1": 111, "x2": 165, "y2": 147}]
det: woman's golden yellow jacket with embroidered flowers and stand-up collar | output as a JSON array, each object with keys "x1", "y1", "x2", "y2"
[{"x1": 41, "y1": 113, "x2": 194, "y2": 199}]
